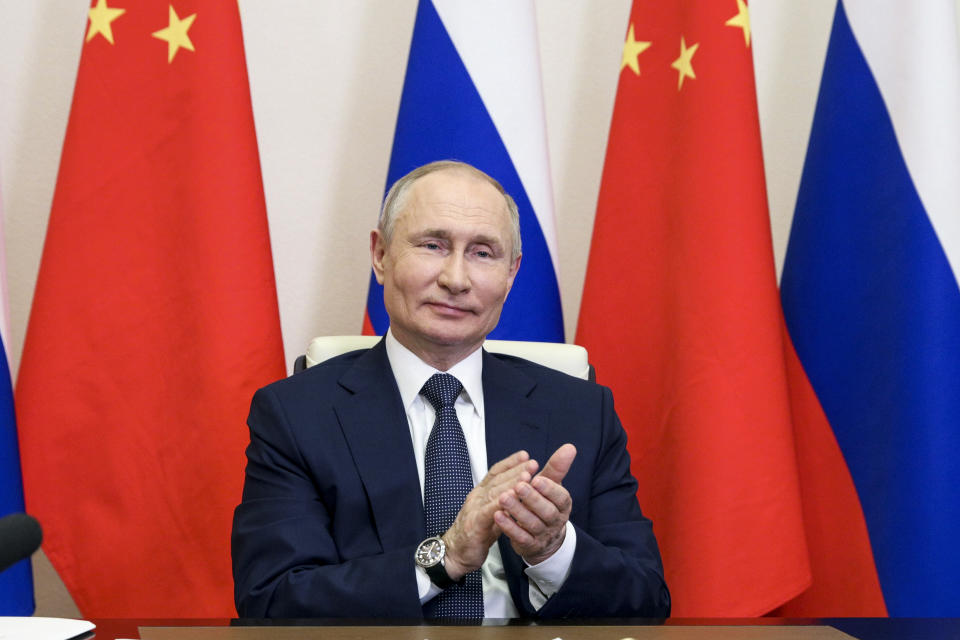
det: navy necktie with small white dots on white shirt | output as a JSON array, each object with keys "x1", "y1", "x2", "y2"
[{"x1": 420, "y1": 373, "x2": 483, "y2": 619}]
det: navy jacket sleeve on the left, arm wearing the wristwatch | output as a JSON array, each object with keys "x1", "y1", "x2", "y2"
[{"x1": 231, "y1": 387, "x2": 422, "y2": 618}]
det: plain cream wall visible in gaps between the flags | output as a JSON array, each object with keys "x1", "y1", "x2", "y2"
[{"x1": 0, "y1": 0, "x2": 960, "y2": 615}]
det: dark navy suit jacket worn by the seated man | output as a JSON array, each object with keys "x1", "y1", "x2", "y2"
[{"x1": 232, "y1": 340, "x2": 670, "y2": 618}]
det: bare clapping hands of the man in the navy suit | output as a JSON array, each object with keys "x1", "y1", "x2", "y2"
[{"x1": 443, "y1": 444, "x2": 577, "y2": 580}]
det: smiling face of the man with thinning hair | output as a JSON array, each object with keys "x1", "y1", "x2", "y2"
[{"x1": 370, "y1": 169, "x2": 520, "y2": 369}]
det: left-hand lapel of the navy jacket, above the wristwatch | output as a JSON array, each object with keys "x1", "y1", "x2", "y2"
[{"x1": 334, "y1": 340, "x2": 426, "y2": 549}]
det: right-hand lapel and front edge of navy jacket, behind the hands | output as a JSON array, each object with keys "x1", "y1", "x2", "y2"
[{"x1": 483, "y1": 351, "x2": 552, "y2": 616}]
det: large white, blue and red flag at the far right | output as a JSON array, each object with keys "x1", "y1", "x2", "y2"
[{"x1": 781, "y1": 0, "x2": 960, "y2": 616}]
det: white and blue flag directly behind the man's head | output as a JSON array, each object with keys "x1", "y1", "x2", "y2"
[{"x1": 364, "y1": 0, "x2": 564, "y2": 342}]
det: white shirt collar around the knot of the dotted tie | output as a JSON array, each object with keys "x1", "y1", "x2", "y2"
[{"x1": 386, "y1": 329, "x2": 483, "y2": 418}]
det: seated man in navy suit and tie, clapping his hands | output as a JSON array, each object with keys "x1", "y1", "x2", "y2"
[{"x1": 232, "y1": 162, "x2": 670, "y2": 618}]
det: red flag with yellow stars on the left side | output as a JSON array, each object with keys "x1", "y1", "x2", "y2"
[{"x1": 16, "y1": 0, "x2": 285, "y2": 618}]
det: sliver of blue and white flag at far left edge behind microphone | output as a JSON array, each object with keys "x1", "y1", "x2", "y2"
[{"x1": 0, "y1": 184, "x2": 34, "y2": 616}]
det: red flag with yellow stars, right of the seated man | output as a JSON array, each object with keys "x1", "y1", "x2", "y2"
[{"x1": 577, "y1": 0, "x2": 810, "y2": 616}]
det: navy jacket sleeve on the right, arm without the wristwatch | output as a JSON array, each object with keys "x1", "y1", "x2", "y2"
[{"x1": 537, "y1": 387, "x2": 670, "y2": 618}]
